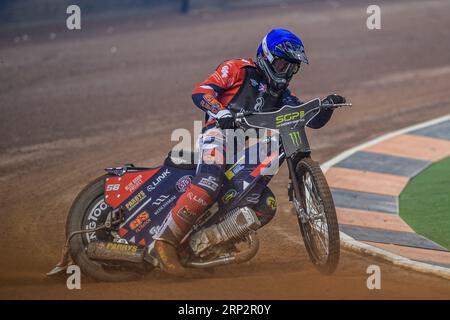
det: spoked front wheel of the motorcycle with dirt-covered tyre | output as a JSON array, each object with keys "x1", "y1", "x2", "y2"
[{"x1": 293, "y1": 157, "x2": 340, "y2": 274}]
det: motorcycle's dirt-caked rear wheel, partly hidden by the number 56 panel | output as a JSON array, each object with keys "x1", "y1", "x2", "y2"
[{"x1": 66, "y1": 175, "x2": 149, "y2": 281}]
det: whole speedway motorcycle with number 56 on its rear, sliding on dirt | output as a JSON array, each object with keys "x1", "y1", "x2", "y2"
[{"x1": 48, "y1": 99, "x2": 351, "y2": 281}]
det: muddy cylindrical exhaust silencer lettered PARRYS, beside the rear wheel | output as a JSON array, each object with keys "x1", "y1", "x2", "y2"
[{"x1": 87, "y1": 241, "x2": 145, "y2": 263}]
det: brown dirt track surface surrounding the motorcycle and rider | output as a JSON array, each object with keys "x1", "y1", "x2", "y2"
[{"x1": 0, "y1": 1, "x2": 450, "y2": 299}]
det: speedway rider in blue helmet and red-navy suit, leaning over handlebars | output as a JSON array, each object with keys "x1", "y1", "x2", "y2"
[{"x1": 151, "y1": 29, "x2": 345, "y2": 275}]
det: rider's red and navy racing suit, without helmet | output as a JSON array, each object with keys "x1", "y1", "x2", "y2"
[{"x1": 162, "y1": 59, "x2": 332, "y2": 238}]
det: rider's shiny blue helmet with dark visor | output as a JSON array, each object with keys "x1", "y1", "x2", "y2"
[{"x1": 256, "y1": 29, "x2": 308, "y2": 91}]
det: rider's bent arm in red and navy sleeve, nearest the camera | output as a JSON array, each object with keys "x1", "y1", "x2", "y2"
[{"x1": 192, "y1": 60, "x2": 244, "y2": 118}]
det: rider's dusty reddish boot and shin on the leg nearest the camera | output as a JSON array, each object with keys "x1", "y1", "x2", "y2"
[{"x1": 153, "y1": 184, "x2": 213, "y2": 276}]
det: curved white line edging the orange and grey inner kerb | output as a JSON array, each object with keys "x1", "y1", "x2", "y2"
[{"x1": 321, "y1": 114, "x2": 450, "y2": 280}]
